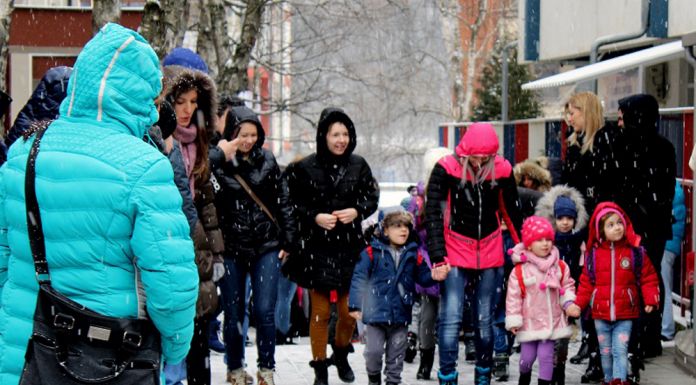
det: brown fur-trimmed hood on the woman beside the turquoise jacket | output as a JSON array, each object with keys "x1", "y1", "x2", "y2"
[{"x1": 165, "y1": 66, "x2": 218, "y2": 136}]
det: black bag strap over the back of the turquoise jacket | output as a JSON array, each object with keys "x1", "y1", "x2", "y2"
[{"x1": 24, "y1": 127, "x2": 51, "y2": 286}]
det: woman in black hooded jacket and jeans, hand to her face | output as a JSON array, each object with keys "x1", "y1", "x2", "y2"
[{"x1": 209, "y1": 106, "x2": 295, "y2": 385}]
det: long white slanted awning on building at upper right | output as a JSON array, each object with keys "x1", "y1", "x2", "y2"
[{"x1": 522, "y1": 40, "x2": 686, "y2": 90}]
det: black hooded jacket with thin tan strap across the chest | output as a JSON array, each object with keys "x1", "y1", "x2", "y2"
[{"x1": 210, "y1": 106, "x2": 295, "y2": 261}]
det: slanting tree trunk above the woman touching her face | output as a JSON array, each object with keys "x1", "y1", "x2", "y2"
[{"x1": 218, "y1": 0, "x2": 268, "y2": 92}]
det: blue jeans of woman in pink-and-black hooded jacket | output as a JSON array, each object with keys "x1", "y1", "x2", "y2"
[{"x1": 438, "y1": 267, "x2": 503, "y2": 375}]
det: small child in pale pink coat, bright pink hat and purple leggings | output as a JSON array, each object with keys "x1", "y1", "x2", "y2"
[{"x1": 505, "y1": 216, "x2": 575, "y2": 385}]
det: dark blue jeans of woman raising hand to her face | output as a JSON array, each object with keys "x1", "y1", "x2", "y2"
[{"x1": 220, "y1": 250, "x2": 280, "y2": 371}]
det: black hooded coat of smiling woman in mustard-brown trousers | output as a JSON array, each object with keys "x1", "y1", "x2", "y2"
[{"x1": 283, "y1": 108, "x2": 379, "y2": 290}]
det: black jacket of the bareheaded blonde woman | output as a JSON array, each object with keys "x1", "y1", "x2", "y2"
[{"x1": 563, "y1": 123, "x2": 625, "y2": 213}]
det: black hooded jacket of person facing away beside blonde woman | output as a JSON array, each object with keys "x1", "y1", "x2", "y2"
[{"x1": 617, "y1": 94, "x2": 677, "y2": 241}]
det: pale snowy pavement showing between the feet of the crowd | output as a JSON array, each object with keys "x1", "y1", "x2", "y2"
[{"x1": 210, "y1": 329, "x2": 696, "y2": 385}]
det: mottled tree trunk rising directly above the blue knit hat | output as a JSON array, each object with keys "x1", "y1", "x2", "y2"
[{"x1": 140, "y1": 0, "x2": 189, "y2": 59}]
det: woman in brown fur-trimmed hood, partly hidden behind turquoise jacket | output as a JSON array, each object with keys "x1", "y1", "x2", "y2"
[{"x1": 165, "y1": 67, "x2": 224, "y2": 384}]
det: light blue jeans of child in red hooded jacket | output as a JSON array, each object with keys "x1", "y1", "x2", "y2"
[{"x1": 595, "y1": 320, "x2": 633, "y2": 383}]
